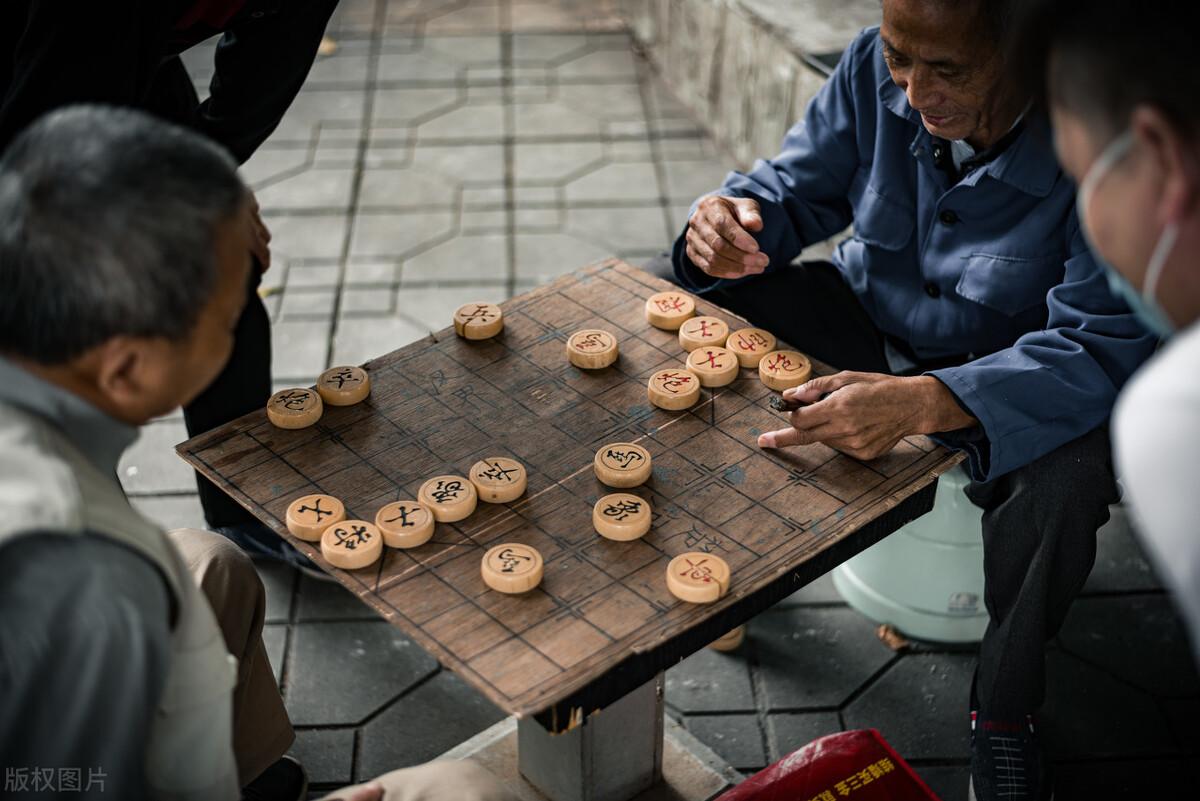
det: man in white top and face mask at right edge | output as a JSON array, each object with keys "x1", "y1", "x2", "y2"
[{"x1": 1022, "y1": 0, "x2": 1200, "y2": 663}]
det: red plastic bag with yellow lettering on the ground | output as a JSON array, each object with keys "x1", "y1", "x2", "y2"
[{"x1": 716, "y1": 729, "x2": 938, "y2": 801}]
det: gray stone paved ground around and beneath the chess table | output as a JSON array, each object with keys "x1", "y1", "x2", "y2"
[{"x1": 114, "y1": 0, "x2": 1200, "y2": 801}]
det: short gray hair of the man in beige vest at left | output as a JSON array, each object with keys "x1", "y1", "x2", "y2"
[{"x1": 0, "y1": 106, "x2": 246, "y2": 365}]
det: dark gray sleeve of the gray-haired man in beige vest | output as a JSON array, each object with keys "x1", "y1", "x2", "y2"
[{"x1": 0, "y1": 535, "x2": 170, "y2": 801}]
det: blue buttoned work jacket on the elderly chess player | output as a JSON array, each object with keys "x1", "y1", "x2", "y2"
[{"x1": 673, "y1": 28, "x2": 1154, "y2": 480}]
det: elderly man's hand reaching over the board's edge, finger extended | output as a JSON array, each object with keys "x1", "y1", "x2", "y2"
[{"x1": 758, "y1": 372, "x2": 978, "y2": 460}]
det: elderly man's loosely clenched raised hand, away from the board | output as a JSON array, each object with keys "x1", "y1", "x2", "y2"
[{"x1": 685, "y1": 194, "x2": 770, "y2": 278}]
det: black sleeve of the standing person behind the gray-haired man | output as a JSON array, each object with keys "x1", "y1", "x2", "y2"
[{"x1": 194, "y1": 0, "x2": 337, "y2": 164}]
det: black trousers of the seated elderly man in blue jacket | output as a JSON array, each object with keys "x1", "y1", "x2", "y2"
[{"x1": 646, "y1": 257, "x2": 1117, "y2": 719}]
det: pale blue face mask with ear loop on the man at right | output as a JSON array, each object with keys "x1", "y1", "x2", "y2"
[{"x1": 1075, "y1": 131, "x2": 1178, "y2": 339}]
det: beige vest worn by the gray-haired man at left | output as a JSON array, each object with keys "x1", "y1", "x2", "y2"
[{"x1": 0, "y1": 403, "x2": 240, "y2": 801}]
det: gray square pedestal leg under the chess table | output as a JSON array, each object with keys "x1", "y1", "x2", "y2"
[{"x1": 517, "y1": 673, "x2": 662, "y2": 801}]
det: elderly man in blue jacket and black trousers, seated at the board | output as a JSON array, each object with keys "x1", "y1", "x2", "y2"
[{"x1": 662, "y1": 0, "x2": 1153, "y2": 799}]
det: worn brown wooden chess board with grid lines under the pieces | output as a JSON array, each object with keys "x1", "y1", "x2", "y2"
[{"x1": 179, "y1": 260, "x2": 959, "y2": 730}]
